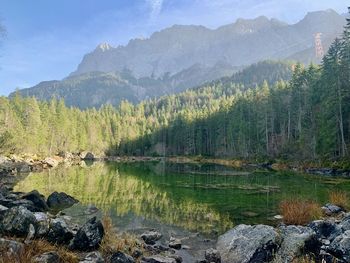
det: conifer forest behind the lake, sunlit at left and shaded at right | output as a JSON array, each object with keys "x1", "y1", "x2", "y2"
[{"x1": 0, "y1": 15, "x2": 350, "y2": 160}]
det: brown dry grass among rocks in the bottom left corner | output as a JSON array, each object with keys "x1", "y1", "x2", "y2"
[{"x1": 0, "y1": 240, "x2": 79, "y2": 263}]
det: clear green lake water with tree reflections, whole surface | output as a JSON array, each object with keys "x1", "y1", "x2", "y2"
[{"x1": 15, "y1": 163, "x2": 350, "y2": 234}]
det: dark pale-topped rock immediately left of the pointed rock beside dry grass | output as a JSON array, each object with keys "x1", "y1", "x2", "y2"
[{"x1": 46, "y1": 218, "x2": 74, "y2": 245}]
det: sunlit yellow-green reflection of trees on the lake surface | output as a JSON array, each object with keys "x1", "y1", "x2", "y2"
[{"x1": 16, "y1": 163, "x2": 232, "y2": 233}]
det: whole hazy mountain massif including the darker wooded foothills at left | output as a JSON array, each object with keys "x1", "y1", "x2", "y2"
[{"x1": 12, "y1": 10, "x2": 345, "y2": 108}]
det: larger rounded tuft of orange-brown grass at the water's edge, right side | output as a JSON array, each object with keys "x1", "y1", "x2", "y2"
[{"x1": 280, "y1": 199, "x2": 322, "y2": 225}]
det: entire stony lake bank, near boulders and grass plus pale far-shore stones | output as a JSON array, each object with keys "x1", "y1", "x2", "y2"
[{"x1": 0, "y1": 152, "x2": 350, "y2": 263}]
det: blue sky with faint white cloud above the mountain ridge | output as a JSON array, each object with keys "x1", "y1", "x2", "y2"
[{"x1": 0, "y1": 0, "x2": 349, "y2": 96}]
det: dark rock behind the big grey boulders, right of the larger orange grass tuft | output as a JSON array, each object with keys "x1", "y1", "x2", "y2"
[{"x1": 309, "y1": 220, "x2": 342, "y2": 241}]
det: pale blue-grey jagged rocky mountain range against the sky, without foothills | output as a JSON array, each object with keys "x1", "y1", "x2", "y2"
[{"x1": 72, "y1": 10, "x2": 345, "y2": 76}]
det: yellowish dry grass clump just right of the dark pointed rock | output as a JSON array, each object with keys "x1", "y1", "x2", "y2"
[{"x1": 100, "y1": 215, "x2": 143, "y2": 257}]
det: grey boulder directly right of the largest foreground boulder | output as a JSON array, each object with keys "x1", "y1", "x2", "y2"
[{"x1": 274, "y1": 226, "x2": 316, "y2": 263}]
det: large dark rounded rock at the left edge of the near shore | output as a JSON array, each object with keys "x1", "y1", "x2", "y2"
[{"x1": 0, "y1": 206, "x2": 37, "y2": 237}]
